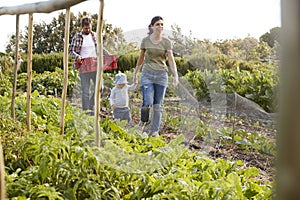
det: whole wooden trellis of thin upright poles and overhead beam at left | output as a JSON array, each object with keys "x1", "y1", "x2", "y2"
[{"x1": 0, "y1": 0, "x2": 104, "y2": 199}]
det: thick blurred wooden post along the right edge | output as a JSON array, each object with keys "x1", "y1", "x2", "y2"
[{"x1": 276, "y1": 0, "x2": 300, "y2": 200}]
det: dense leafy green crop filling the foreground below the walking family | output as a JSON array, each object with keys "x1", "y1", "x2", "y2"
[{"x1": 0, "y1": 91, "x2": 274, "y2": 200}]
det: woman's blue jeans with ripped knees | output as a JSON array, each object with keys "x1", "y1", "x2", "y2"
[{"x1": 141, "y1": 71, "x2": 168, "y2": 132}]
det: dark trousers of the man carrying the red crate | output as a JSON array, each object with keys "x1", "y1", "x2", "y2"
[{"x1": 79, "y1": 72, "x2": 97, "y2": 110}]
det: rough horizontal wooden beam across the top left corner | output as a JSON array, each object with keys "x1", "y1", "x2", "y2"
[{"x1": 0, "y1": 0, "x2": 86, "y2": 15}]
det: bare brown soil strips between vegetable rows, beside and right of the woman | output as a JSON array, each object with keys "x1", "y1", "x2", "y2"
[{"x1": 126, "y1": 96, "x2": 277, "y2": 182}]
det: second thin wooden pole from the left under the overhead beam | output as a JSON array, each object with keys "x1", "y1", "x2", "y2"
[{"x1": 26, "y1": 13, "x2": 33, "y2": 131}]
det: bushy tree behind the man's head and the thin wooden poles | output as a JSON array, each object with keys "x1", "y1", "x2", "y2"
[{"x1": 6, "y1": 12, "x2": 125, "y2": 54}]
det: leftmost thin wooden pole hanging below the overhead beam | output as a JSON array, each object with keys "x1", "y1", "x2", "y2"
[{"x1": 11, "y1": 15, "x2": 20, "y2": 119}]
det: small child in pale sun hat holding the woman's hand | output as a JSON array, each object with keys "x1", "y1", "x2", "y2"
[{"x1": 109, "y1": 73, "x2": 136, "y2": 122}]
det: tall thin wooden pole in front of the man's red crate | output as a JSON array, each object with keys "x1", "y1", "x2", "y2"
[{"x1": 94, "y1": 0, "x2": 104, "y2": 147}]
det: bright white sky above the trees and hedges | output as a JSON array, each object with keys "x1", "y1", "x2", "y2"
[{"x1": 0, "y1": 0, "x2": 281, "y2": 52}]
